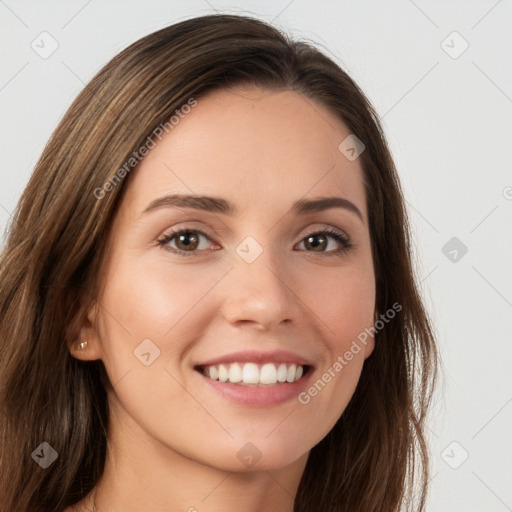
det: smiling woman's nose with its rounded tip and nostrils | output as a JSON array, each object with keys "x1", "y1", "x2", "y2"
[{"x1": 222, "y1": 246, "x2": 299, "y2": 331}]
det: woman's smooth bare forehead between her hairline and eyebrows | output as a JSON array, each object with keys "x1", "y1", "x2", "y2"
[{"x1": 122, "y1": 86, "x2": 366, "y2": 218}]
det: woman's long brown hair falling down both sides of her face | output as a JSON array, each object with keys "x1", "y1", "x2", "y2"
[{"x1": 0, "y1": 14, "x2": 438, "y2": 512}]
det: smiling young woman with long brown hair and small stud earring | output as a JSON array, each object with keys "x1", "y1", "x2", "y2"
[{"x1": 0, "y1": 15, "x2": 437, "y2": 512}]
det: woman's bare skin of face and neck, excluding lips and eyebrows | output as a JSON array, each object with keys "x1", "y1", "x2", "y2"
[{"x1": 68, "y1": 86, "x2": 376, "y2": 512}]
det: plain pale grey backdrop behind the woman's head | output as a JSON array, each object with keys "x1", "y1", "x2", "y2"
[{"x1": 0, "y1": 0, "x2": 512, "y2": 512}]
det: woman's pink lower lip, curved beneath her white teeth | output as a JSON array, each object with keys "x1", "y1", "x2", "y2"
[{"x1": 194, "y1": 367, "x2": 313, "y2": 407}]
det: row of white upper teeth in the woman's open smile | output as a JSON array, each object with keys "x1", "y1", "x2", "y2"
[{"x1": 203, "y1": 363, "x2": 304, "y2": 386}]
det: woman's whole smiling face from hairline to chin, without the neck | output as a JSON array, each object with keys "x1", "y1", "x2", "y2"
[{"x1": 76, "y1": 87, "x2": 375, "y2": 471}]
